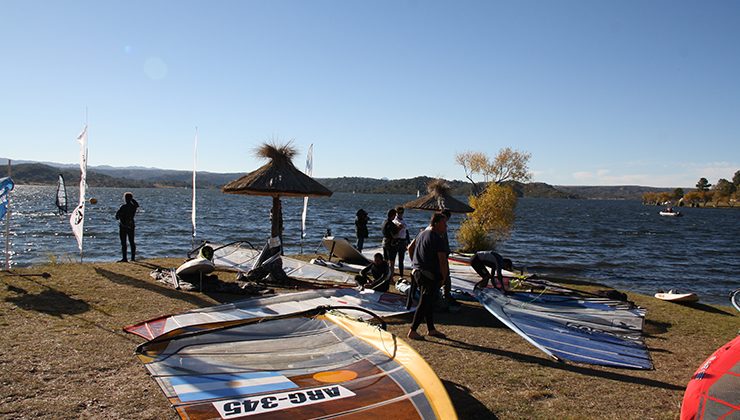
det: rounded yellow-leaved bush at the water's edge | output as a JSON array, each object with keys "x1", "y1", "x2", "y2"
[{"x1": 457, "y1": 184, "x2": 517, "y2": 252}]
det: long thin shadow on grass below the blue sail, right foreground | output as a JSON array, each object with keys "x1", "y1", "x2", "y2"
[{"x1": 435, "y1": 338, "x2": 686, "y2": 391}]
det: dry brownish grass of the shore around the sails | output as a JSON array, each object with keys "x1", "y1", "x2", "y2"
[{"x1": 0, "y1": 259, "x2": 740, "y2": 419}]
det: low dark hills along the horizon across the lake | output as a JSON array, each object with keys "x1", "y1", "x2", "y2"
[{"x1": 0, "y1": 159, "x2": 690, "y2": 200}]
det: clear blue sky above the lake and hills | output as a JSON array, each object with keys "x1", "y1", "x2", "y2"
[{"x1": 0, "y1": 0, "x2": 740, "y2": 187}]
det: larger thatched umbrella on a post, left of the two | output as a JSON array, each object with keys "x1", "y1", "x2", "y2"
[{"x1": 221, "y1": 143, "x2": 332, "y2": 244}]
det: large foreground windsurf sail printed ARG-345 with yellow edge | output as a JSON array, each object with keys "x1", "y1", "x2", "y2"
[{"x1": 137, "y1": 308, "x2": 457, "y2": 419}]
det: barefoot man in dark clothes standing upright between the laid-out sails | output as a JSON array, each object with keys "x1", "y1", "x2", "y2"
[{"x1": 407, "y1": 213, "x2": 450, "y2": 340}]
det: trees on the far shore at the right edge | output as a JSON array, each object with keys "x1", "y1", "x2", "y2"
[{"x1": 642, "y1": 170, "x2": 740, "y2": 207}]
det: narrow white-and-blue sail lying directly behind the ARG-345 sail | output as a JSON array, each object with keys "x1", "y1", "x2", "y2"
[{"x1": 124, "y1": 289, "x2": 411, "y2": 340}]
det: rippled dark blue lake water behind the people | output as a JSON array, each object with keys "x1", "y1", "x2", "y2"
[{"x1": 0, "y1": 185, "x2": 740, "y2": 305}]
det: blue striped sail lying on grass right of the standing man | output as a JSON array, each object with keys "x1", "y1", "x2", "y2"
[{"x1": 450, "y1": 265, "x2": 653, "y2": 369}]
